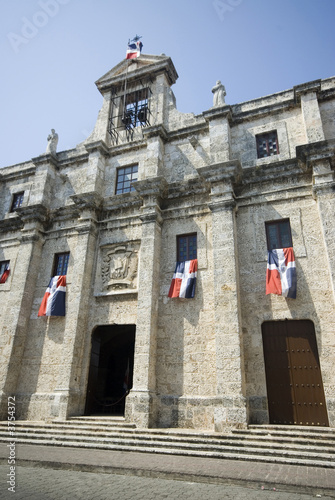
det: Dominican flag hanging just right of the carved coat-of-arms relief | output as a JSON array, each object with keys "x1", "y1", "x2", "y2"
[{"x1": 168, "y1": 259, "x2": 198, "y2": 299}]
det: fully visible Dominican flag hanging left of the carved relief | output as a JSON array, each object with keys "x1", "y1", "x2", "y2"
[{"x1": 38, "y1": 276, "x2": 66, "y2": 316}]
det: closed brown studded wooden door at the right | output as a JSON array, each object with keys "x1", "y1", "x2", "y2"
[{"x1": 262, "y1": 320, "x2": 329, "y2": 426}]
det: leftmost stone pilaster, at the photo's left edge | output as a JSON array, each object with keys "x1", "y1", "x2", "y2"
[{"x1": 0, "y1": 205, "x2": 48, "y2": 418}]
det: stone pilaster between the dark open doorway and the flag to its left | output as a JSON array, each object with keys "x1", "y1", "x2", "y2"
[{"x1": 51, "y1": 193, "x2": 102, "y2": 419}]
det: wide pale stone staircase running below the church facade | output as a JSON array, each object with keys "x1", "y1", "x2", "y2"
[{"x1": 0, "y1": 417, "x2": 335, "y2": 468}]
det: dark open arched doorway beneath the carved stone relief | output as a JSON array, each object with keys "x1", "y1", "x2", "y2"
[{"x1": 85, "y1": 325, "x2": 136, "y2": 416}]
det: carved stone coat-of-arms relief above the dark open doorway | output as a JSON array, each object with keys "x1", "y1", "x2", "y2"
[{"x1": 101, "y1": 245, "x2": 138, "y2": 290}]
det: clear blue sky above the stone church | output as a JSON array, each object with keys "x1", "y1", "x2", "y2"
[{"x1": 0, "y1": 0, "x2": 335, "y2": 167}]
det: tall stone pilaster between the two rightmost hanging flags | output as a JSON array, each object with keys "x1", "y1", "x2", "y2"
[{"x1": 198, "y1": 162, "x2": 247, "y2": 430}]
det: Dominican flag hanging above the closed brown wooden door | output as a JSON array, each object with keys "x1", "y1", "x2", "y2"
[{"x1": 266, "y1": 247, "x2": 297, "y2": 299}]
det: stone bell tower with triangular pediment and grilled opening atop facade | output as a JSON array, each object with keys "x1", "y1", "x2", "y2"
[{"x1": 89, "y1": 54, "x2": 178, "y2": 146}]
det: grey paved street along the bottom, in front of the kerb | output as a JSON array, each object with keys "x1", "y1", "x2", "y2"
[{"x1": 0, "y1": 465, "x2": 335, "y2": 500}]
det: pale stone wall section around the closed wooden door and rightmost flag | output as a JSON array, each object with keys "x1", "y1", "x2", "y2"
[{"x1": 238, "y1": 179, "x2": 335, "y2": 423}]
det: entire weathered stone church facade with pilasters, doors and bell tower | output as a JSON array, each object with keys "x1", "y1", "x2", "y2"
[{"x1": 0, "y1": 54, "x2": 335, "y2": 431}]
